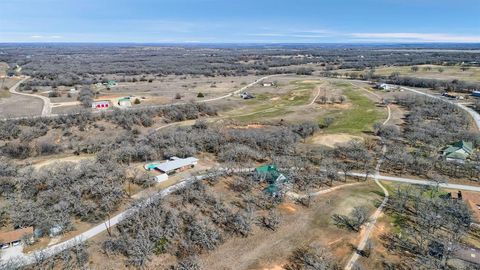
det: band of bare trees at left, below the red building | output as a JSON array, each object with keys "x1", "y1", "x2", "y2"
[{"x1": 0, "y1": 103, "x2": 217, "y2": 159}]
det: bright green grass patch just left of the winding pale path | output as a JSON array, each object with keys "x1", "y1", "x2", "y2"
[{"x1": 320, "y1": 83, "x2": 387, "y2": 134}]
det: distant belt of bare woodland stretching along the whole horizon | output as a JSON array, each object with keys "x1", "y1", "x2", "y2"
[{"x1": 0, "y1": 45, "x2": 478, "y2": 86}]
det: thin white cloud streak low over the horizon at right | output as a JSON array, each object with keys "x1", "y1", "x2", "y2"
[{"x1": 350, "y1": 33, "x2": 480, "y2": 42}]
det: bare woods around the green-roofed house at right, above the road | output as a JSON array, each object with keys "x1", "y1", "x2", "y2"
[{"x1": 376, "y1": 95, "x2": 480, "y2": 181}]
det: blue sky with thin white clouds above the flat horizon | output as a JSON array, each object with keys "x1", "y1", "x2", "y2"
[{"x1": 0, "y1": 0, "x2": 480, "y2": 43}]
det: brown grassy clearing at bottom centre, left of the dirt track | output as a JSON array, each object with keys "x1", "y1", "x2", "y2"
[{"x1": 202, "y1": 182, "x2": 381, "y2": 269}]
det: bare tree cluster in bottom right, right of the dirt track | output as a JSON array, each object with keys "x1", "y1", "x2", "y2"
[{"x1": 382, "y1": 187, "x2": 474, "y2": 269}]
